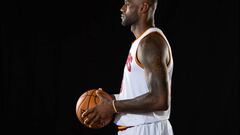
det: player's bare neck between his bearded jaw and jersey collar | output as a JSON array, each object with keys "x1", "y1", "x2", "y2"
[{"x1": 131, "y1": 21, "x2": 155, "y2": 38}]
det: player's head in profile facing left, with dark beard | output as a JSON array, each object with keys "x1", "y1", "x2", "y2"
[{"x1": 121, "y1": 0, "x2": 157, "y2": 26}]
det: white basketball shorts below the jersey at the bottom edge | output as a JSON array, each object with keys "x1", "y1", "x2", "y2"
[{"x1": 118, "y1": 120, "x2": 173, "y2": 135}]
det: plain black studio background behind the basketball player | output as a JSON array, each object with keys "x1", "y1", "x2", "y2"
[{"x1": 0, "y1": 0, "x2": 239, "y2": 135}]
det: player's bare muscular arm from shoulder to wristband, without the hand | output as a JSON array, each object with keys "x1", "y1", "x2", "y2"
[{"x1": 115, "y1": 33, "x2": 169, "y2": 113}]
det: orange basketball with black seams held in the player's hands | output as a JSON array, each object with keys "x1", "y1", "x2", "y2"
[{"x1": 76, "y1": 89, "x2": 112, "y2": 129}]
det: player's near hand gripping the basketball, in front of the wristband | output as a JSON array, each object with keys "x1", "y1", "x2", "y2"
[{"x1": 82, "y1": 88, "x2": 114, "y2": 127}]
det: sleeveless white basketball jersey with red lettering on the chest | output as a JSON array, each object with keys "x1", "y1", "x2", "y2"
[{"x1": 115, "y1": 28, "x2": 173, "y2": 126}]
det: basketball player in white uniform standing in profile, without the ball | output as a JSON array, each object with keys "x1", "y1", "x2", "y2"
[{"x1": 82, "y1": 0, "x2": 173, "y2": 135}]
